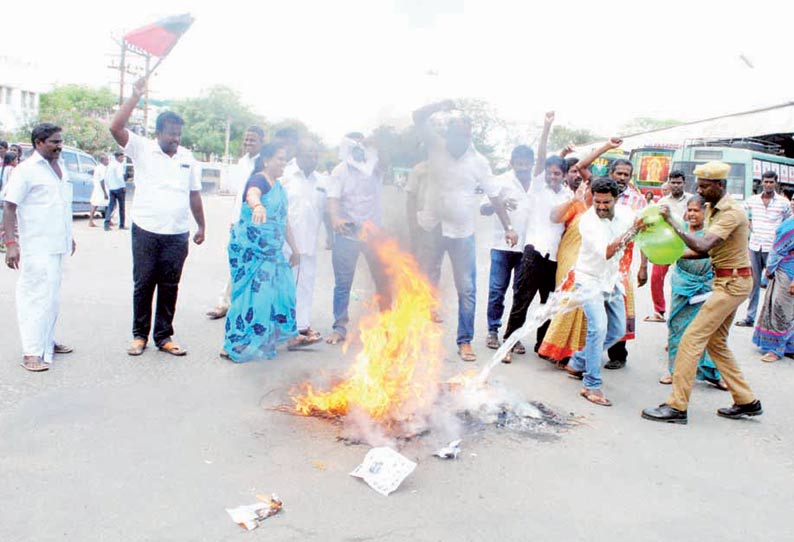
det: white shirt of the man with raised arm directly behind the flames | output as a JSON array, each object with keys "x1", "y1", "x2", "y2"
[{"x1": 416, "y1": 146, "x2": 499, "y2": 239}]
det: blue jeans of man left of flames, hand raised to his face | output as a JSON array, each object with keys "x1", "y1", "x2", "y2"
[{"x1": 331, "y1": 235, "x2": 391, "y2": 337}]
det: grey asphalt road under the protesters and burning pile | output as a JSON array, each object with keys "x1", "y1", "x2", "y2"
[{"x1": 0, "y1": 188, "x2": 794, "y2": 542}]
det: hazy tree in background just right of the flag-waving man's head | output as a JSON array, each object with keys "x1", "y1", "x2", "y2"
[{"x1": 171, "y1": 85, "x2": 265, "y2": 160}]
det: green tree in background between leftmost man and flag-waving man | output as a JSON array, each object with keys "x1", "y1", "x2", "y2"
[{"x1": 18, "y1": 85, "x2": 116, "y2": 155}]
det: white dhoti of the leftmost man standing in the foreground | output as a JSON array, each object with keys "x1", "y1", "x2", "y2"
[{"x1": 17, "y1": 254, "x2": 64, "y2": 363}]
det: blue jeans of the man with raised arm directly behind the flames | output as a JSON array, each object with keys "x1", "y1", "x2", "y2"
[{"x1": 418, "y1": 227, "x2": 477, "y2": 345}]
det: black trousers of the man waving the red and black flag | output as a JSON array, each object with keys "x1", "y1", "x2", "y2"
[{"x1": 132, "y1": 224, "x2": 188, "y2": 346}]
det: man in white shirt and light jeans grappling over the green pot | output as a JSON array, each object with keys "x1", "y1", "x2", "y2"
[{"x1": 565, "y1": 177, "x2": 641, "y2": 406}]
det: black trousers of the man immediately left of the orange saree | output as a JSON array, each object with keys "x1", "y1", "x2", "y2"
[{"x1": 505, "y1": 245, "x2": 557, "y2": 352}]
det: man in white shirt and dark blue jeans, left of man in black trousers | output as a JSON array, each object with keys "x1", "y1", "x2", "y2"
[{"x1": 480, "y1": 145, "x2": 535, "y2": 350}]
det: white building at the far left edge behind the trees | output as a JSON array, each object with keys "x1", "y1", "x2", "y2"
[{"x1": 0, "y1": 56, "x2": 50, "y2": 134}]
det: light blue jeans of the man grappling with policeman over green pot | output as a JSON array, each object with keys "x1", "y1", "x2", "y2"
[{"x1": 569, "y1": 284, "x2": 626, "y2": 390}]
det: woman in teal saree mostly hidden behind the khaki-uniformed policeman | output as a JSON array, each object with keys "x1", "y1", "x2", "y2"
[{"x1": 659, "y1": 196, "x2": 728, "y2": 390}]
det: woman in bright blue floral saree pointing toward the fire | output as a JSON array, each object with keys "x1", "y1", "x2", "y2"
[{"x1": 221, "y1": 143, "x2": 317, "y2": 363}]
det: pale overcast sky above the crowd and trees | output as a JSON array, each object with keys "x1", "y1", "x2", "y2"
[{"x1": 0, "y1": 0, "x2": 794, "y2": 143}]
